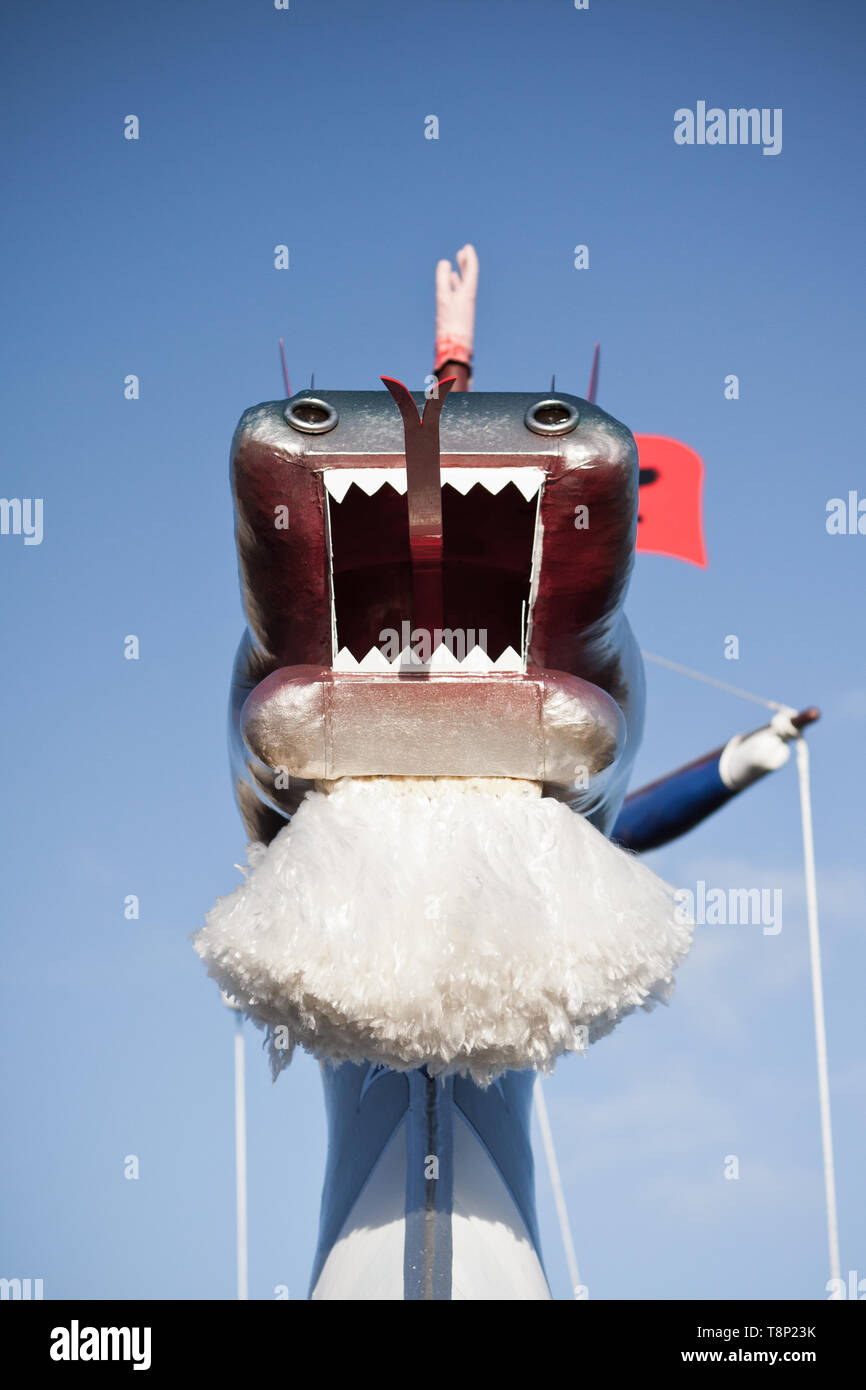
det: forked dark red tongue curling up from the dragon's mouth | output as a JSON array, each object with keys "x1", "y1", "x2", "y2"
[{"x1": 381, "y1": 377, "x2": 455, "y2": 648}]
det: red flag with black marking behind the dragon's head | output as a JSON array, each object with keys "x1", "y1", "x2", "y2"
[{"x1": 634, "y1": 435, "x2": 706, "y2": 569}]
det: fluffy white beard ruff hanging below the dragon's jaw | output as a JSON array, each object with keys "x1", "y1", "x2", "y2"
[{"x1": 195, "y1": 778, "x2": 692, "y2": 1084}]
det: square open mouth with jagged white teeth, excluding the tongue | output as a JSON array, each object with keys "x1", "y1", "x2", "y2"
[{"x1": 324, "y1": 467, "x2": 545, "y2": 671}]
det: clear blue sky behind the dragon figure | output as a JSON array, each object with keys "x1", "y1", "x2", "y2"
[{"x1": 0, "y1": 0, "x2": 866, "y2": 1298}]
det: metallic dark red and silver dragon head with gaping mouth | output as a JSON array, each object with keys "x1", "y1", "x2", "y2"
[{"x1": 232, "y1": 378, "x2": 641, "y2": 824}]
